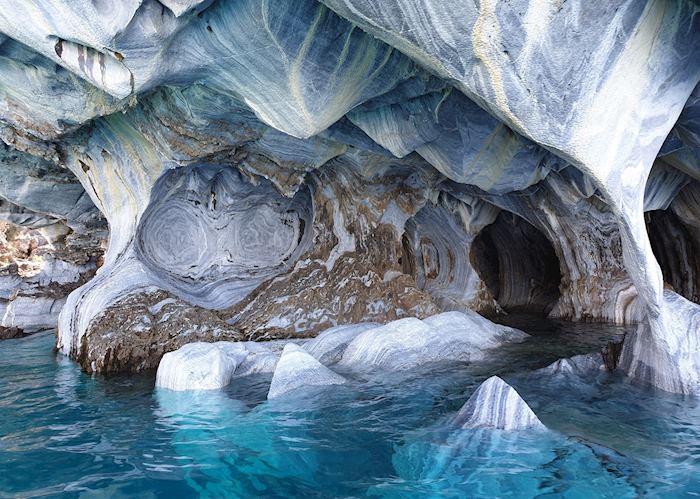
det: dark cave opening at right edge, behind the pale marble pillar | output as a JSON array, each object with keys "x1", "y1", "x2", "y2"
[{"x1": 645, "y1": 209, "x2": 700, "y2": 303}]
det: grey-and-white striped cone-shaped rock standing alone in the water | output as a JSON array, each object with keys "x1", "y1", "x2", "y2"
[{"x1": 455, "y1": 376, "x2": 546, "y2": 430}]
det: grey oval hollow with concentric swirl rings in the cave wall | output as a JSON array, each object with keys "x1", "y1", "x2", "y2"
[{"x1": 136, "y1": 165, "x2": 311, "y2": 308}]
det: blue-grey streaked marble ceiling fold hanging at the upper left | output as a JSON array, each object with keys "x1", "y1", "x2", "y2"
[{"x1": 0, "y1": 0, "x2": 414, "y2": 138}]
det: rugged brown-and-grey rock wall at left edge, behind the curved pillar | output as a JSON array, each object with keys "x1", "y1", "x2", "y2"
[{"x1": 0, "y1": 145, "x2": 107, "y2": 338}]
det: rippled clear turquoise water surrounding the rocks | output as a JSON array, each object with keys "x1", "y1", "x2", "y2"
[{"x1": 0, "y1": 322, "x2": 700, "y2": 498}]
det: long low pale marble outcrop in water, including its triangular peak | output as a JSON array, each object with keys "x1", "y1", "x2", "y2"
[{"x1": 154, "y1": 312, "x2": 527, "y2": 392}]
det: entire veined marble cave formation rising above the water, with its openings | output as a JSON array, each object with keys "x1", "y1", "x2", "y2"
[{"x1": 0, "y1": 0, "x2": 700, "y2": 393}]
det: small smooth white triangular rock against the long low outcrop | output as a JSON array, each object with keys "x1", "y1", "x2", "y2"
[{"x1": 267, "y1": 343, "x2": 346, "y2": 399}]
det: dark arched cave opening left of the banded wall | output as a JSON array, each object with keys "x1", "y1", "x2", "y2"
[{"x1": 470, "y1": 211, "x2": 561, "y2": 315}]
